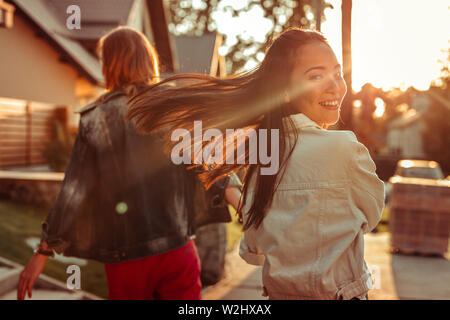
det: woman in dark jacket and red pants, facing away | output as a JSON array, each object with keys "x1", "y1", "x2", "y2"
[{"x1": 17, "y1": 27, "x2": 241, "y2": 299}]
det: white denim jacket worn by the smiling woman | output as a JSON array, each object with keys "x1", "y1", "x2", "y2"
[{"x1": 240, "y1": 113, "x2": 384, "y2": 300}]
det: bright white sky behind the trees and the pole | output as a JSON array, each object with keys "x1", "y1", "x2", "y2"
[{"x1": 208, "y1": 0, "x2": 450, "y2": 91}]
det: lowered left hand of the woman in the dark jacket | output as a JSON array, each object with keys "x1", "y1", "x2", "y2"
[{"x1": 17, "y1": 253, "x2": 48, "y2": 300}]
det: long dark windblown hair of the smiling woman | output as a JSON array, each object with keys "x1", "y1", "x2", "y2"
[{"x1": 127, "y1": 28, "x2": 328, "y2": 230}]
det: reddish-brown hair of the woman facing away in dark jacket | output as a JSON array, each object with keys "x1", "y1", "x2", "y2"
[{"x1": 97, "y1": 26, "x2": 159, "y2": 96}]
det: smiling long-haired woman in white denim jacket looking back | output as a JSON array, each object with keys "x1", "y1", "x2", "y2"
[{"x1": 127, "y1": 28, "x2": 384, "y2": 299}]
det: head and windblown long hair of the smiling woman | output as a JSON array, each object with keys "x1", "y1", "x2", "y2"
[{"x1": 127, "y1": 28, "x2": 332, "y2": 228}]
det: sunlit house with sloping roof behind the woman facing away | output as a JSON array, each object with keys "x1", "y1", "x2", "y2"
[{"x1": 0, "y1": 0, "x2": 172, "y2": 117}]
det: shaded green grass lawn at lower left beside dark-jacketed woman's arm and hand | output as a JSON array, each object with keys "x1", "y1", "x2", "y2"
[{"x1": 0, "y1": 199, "x2": 108, "y2": 299}]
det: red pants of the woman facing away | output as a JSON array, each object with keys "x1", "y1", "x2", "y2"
[{"x1": 105, "y1": 240, "x2": 202, "y2": 300}]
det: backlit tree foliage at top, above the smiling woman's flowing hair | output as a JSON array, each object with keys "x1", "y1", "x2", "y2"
[{"x1": 165, "y1": 0, "x2": 332, "y2": 73}]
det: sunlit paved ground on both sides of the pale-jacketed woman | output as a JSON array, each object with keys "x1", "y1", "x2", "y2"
[{"x1": 203, "y1": 233, "x2": 450, "y2": 300}]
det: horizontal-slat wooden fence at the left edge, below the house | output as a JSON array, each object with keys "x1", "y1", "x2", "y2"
[{"x1": 0, "y1": 98, "x2": 64, "y2": 168}]
